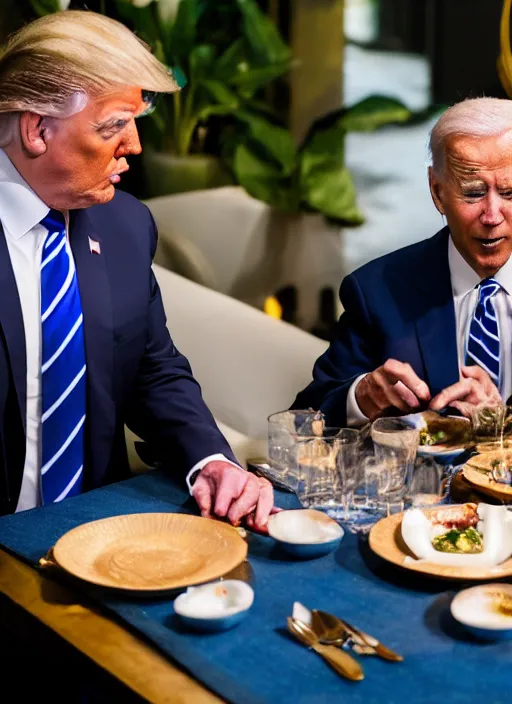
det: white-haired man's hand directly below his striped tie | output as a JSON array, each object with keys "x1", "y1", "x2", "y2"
[{"x1": 430, "y1": 365, "x2": 503, "y2": 418}]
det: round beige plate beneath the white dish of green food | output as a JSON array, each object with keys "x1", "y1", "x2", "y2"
[{"x1": 370, "y1": 509, "x2": 512, "y2": 579}]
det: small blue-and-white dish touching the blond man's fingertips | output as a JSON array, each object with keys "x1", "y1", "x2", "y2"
[{"x1": 267, "y1": 508, "x2": 344, "y2": 559}]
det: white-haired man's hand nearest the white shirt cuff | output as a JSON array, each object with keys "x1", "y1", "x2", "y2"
[{"x1": 355, "y1": 359, "x2": 430, "y2": 420}]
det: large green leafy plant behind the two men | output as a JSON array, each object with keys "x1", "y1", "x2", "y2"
[{"x1": 30, "y1": 0, "x2": 436, "y2": 225}]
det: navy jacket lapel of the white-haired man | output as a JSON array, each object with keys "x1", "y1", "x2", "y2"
[{"x1": 415, "y1": 228, "x2": 460, "y2": 396}]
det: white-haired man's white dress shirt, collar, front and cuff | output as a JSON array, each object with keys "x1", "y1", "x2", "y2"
[{"x1": 347, "y1": 237, "x2": 512, "y2": 426}]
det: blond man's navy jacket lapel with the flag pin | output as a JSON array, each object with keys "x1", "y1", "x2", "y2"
[{"x1": 70, "y1": 210, "x2": 115, "y2": 486}]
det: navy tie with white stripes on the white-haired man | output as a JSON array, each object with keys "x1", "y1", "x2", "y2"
[{"x1": 466, "y1": 279, "x2": 501, "y2": 386}]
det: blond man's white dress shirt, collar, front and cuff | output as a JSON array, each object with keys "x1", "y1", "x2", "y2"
[{"x1": 0, "y1": 149, "x2": 238, "y2": 511}]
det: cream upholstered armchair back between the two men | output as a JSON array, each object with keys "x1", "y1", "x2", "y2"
[{"x1": 128, "y1": 265, "x2": 327, "y2": 470}]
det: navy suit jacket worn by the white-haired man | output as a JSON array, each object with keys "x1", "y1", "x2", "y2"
[{"x1": 292, "y1": 228, "x2": 459, "y2": 426}]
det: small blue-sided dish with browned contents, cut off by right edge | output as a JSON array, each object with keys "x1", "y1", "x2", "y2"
[{"x1": 450, "y1": 583, "x2": 512, "y2": 640}]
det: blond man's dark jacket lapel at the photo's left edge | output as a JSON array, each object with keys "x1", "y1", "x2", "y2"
[{"x1": 0, "y1": 224, "x2": 27, "y2": 432}]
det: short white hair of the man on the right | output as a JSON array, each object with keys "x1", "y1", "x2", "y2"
[{"x1": 429, "y1": 98, "x2": 512, "y2": 173}]
